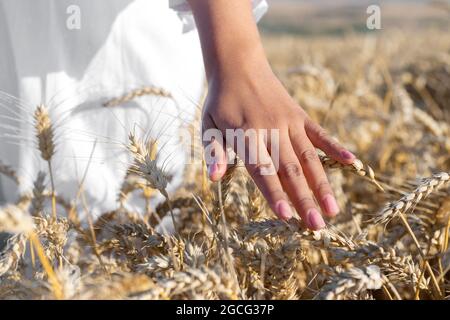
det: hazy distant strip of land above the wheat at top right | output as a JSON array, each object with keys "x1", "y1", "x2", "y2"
[{"x1": 260, "y1": 0, "x2": 450, "y2": 37}]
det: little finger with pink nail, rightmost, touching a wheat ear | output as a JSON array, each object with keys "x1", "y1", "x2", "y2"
[{"x1": 305, "y1": 120, "x2": 356, "y2": 164}]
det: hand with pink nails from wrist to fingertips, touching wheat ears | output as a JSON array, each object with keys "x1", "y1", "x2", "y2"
[{"x1": 203, "y1": 59, "x2": 355, "y2": 230}]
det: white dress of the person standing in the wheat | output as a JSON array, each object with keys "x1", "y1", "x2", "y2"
[{"x1": 0, "y1": 0, "x2": 266, "y2": 218}]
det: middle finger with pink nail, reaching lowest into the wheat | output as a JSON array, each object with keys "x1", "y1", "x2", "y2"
[{"x1": 278, "y1": 133, "x2": 325, "y2": 230}]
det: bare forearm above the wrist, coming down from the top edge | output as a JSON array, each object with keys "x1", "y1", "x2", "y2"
[{"x1": 188, "y1": 0, "x2": 268, "y2": 80}]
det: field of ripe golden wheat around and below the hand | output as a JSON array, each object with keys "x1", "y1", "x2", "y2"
[{"x1": 0, "y1": 4, "x2": 450, "y2": 300}]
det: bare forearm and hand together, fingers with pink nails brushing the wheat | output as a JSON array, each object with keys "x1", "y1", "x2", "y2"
[{"x1": 188, "y1": 0, "x2": 355, "y2": 230}]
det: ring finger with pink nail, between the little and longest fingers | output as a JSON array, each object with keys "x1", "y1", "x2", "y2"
[{"x1": 290, "y1": 129, "x2": 339, "y2": 217}]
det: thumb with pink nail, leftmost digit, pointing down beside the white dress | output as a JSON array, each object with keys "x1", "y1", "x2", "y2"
[{"x1": 202, "y1": 116, "x2": 227, "y2": 181}]
